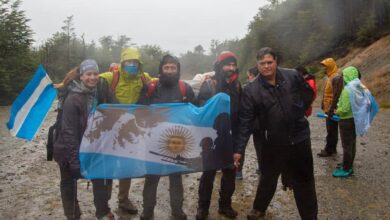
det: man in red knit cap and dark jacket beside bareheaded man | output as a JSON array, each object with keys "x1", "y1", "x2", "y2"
[{"x1": 196, "y1": 51, "x2": 241, "y2": 220}]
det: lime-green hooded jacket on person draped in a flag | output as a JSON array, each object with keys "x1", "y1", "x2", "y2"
[{"x1": 336, "y1": 67, "x2": 359, "y2": 119}]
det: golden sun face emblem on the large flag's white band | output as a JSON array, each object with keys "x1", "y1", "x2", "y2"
[{"x1": 159, "y1": 125, "x2": 194, "y2": 157}]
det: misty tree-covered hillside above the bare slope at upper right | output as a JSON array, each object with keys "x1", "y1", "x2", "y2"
[{"x1": 239, "y1": 0, "x2": 390, "y2": 68}]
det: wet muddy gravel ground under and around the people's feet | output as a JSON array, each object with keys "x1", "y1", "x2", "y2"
[{"x1": 0, "y1": 104, "x2": 390, "y2": 220}]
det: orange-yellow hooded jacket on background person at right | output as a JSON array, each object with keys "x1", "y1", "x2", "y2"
[{"x1": 321, "y1": 58, "x2": 338, "y2": 113}]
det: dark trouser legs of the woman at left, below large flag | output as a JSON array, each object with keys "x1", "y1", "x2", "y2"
[{"x1": 60, "y1": 167, "x2": 112, "y2": 220}]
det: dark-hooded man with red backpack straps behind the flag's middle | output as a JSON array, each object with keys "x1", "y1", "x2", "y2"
[{"x1": 139, "y1": 55, "x2": 194, "y2": 220}]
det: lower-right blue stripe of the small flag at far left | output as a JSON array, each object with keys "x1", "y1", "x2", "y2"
[{"x1": 16, "y1": 84, "x2": 57, "y2": 141}]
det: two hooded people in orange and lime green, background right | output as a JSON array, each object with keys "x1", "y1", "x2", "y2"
[{"x1": 317, "y1": 58, "x2": 377, "y2": 177}]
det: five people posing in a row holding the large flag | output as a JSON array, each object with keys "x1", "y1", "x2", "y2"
[{"x1": 50, "y1": 47, "x2": 374, "y2": 220}]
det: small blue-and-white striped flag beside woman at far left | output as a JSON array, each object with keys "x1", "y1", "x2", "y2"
[{"x1": 7, "y1": 65, "x2": 57, "y2": 141}]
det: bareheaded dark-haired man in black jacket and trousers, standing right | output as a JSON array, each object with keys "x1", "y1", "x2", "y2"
[{"x1": 236, "y1": 47, "x2": 317, "y2": 219}]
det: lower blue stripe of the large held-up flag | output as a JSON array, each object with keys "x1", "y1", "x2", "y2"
[{"x1": 79, "y1": 152, "x2": 190, "y2": 179}]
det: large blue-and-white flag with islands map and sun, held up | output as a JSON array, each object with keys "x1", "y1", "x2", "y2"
[{"x1": 79, "y1": 93, "x2": 233, "y2": 179}]
